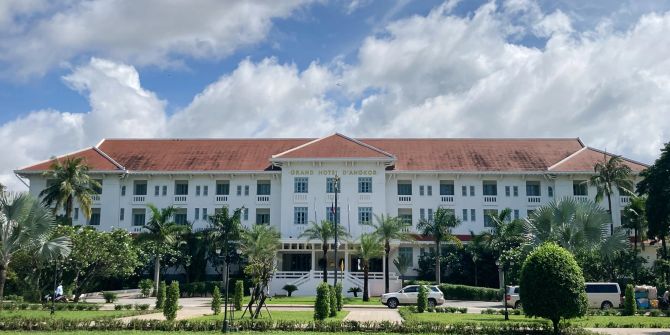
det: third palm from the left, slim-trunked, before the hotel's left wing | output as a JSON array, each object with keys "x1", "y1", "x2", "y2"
[{"x1": 137, "y1": 204, "x2": 189, "y2": 292}]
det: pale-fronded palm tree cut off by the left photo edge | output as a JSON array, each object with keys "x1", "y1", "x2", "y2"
[{"x1": 0, "y1": 193, "x2": 72, "y2": 308}]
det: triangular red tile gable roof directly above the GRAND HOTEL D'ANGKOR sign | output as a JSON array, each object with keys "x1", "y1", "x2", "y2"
[{"x1": 272, "y1": 134, "x2": 394, "y2": 160}]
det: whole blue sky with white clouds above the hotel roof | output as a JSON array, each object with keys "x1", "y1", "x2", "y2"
[{"x1": 0, "y1": 0, "x2": 670, "y2": 190}]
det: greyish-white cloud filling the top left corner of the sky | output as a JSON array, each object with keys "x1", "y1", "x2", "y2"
[{"x1": 0, "y1": 0, "x2": 311, "y2": 77}]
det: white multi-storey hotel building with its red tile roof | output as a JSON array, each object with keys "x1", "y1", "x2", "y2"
[{"x1": 16, "y1": 134, "x2": 646, "y2": 295}]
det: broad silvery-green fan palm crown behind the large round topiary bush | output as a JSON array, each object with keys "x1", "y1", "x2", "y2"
[{"x1": 524, "y1": 197, "x2": 628, "y2": 258}]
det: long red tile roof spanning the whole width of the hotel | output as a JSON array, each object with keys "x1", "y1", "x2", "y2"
[{"x1": 15, "y1": 134, "x2": 646, "y2": 172}]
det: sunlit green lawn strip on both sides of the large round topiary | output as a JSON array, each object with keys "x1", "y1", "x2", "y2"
[{"x1": 403, "y1": 313, "x2": 670, "y2": 328}]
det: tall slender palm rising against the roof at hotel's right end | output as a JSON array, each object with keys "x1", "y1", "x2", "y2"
[{"x1": 589, "y1": 155, "x2": 633, "y2": 234}]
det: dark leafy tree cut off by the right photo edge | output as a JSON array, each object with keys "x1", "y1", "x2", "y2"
[{"x1": 637, "y1": 142, "x2": 670, "y2": 259}]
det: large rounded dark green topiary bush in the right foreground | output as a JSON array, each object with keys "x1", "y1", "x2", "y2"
[{"x1": 519, "y1": 243, "x2": 588, "y2": 334}]
